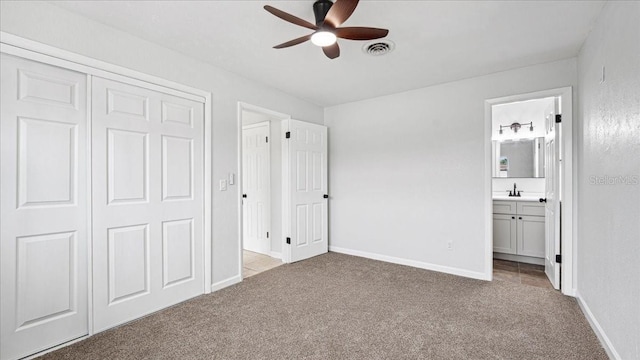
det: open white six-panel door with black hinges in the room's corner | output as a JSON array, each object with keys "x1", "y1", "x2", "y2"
[{"x1": 282, "y1": 120, "x2": 329, "y2": 262}]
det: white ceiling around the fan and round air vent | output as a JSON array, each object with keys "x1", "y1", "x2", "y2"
[{"x1": 54, "y1": 0, "x2": 604, "y2": 106}]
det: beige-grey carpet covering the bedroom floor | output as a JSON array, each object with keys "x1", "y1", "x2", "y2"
[{"x1": 45, "y1": 253, "x2": 607, "y2": 359}]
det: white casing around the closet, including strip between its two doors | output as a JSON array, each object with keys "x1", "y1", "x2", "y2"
[{"x1": 0, "y1": 31, "x2": 213, "y2": 344}]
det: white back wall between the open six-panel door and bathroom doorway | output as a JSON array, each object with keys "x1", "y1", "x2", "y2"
[{"x1": 325, "y1": 59, "x2": 576, "y2": 277}]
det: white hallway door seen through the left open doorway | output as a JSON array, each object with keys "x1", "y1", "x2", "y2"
[{"x1": 242, "y1": 121, "x2": 271, "y2": 255}]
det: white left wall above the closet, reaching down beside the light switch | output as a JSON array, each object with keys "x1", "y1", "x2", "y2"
[{"x1": 0, "y1": 1, "x2": 323, "y2": 283}]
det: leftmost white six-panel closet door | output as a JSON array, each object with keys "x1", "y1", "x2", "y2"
[{"x1": 0, "y1": 54, "x2": 88, "y2": 359}]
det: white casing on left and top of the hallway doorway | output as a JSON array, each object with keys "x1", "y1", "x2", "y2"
[{"x1": 237, "y1": 101, "x2": 291, "y2": 281}]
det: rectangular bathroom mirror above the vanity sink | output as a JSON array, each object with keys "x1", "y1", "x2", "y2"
[{"x1": 492, "y1": 137, "x2": 544, "y2": 178}]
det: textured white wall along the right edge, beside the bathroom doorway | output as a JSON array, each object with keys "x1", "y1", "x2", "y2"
[{"x1": 577, "y1": 1, "x2": 640, "y2": 359}]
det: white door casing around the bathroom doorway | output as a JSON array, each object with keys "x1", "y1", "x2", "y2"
[{"x1": 484, "y1": 86, "x2": 578, "y2": 296}]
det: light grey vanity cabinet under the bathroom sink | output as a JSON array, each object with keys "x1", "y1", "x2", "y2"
[{"x1": 493, "y1": 200, "x2": 545, "y2": 258}]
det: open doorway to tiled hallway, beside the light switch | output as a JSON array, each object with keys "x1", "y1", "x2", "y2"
[{"x1": 238, "y1": 103, "x2": 289, "y2": 278}]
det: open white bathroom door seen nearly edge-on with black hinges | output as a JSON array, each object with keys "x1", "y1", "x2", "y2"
[{"x1": 544, "y1": 100, "x2": 560, "y2": 289}]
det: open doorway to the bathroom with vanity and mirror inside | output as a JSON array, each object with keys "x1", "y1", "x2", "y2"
[{"x1": 487, "y1": 88, "x2": 574, "y2": 295}]
